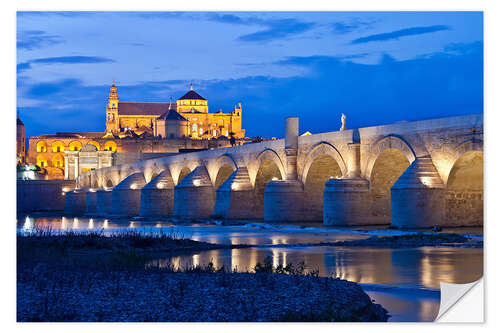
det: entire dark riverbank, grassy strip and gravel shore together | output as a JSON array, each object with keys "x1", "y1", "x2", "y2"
[{"x1": 17, "y1": 232, "x2": 388, "y2": 321}]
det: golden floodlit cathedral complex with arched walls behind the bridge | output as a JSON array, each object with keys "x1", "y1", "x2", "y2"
[{"x1": 25, "y1": 82, "x2": 251, "y2": 179}]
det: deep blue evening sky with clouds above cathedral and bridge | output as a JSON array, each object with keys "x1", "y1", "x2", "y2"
[{"x1": 17, "y1": 12, "x2": 483, "y2": 137}]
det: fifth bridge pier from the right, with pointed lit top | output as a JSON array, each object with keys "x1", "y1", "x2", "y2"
[{"x1": 173, "y1": 165, "x2": 215, "y2": 219}]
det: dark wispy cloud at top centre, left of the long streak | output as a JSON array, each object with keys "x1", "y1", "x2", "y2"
[{"x1": 238, "y1": 19, "x2": 315, "y2": 42}]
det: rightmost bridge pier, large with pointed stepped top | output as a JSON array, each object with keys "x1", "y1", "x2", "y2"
[{"x1": 391, "y1": 156, "x2": 445, "y2": 228}]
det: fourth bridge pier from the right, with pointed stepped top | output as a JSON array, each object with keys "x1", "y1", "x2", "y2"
[{"x1": 212, "y1": 167, "x2": 259, "y2": 219}]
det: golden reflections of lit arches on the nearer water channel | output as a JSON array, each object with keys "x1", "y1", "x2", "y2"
[{"x1": 146, "y1": 246, "x2": 482, "y2": 289}]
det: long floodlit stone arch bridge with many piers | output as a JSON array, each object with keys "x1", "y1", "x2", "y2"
[{"x1": 66, "y1": 114, "x2": 483, "y2": 228}]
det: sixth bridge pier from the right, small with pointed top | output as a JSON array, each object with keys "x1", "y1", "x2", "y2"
[{"x1": 139, "y1": 169, "x2": 174, "y2": 217}]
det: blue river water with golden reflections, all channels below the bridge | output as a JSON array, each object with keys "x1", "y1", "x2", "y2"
[{"x1": 17, "y1": 216, "x2": 483, "y2": 321}]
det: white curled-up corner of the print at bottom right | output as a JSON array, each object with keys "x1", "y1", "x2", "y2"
[{"x1": 435, "y1": 278, "x2": 484, "y2": 323}]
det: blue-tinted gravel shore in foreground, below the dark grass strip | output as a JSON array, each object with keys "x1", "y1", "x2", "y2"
[{"x1": 17, "y1": 265, "x2": 388, "y2": 322}]
